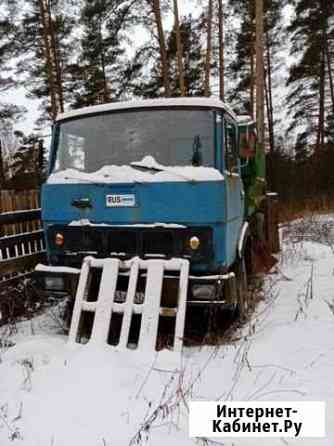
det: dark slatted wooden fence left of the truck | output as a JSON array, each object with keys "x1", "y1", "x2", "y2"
[{"x1": 0, "y1": 190, "x2": 45, "y2": 287}]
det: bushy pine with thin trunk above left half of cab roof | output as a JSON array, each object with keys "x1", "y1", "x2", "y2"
[{"x1": 69, "y1": 0, "x2": 133, "y2": 108}]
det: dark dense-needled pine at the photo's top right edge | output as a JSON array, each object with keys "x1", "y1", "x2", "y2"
[{"x1": 288, "y1": 0, "x2": 334, "y2": 153}]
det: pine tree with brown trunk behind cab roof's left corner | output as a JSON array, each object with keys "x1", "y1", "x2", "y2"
[{"x1": 15, "y1": 0, "x2": 74, "y2": 120}]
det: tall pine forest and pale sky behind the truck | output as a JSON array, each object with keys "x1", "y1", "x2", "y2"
[{"x1": 0, "y1": 0, "x2": 334, "y2": 216}]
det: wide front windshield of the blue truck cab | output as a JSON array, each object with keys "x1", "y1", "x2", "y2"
[{"x1": 53, "y1": 109, "x2": 215, "y2": 172}]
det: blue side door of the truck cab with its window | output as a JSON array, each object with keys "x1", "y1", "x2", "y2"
[{"x1": 223, "y1": 114, "x2": 245, "y2": 266}]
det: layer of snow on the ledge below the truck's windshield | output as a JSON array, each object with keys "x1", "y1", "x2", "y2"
[{"x1": 47, "y1": 156, "x2": 224, "y2": 184}]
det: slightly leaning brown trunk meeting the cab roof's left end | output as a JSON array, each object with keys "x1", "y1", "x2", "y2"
[{"x1": 38, "y1": 0, "x2": 58, "y2": 121}]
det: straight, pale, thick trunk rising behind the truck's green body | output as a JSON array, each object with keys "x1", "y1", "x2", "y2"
[{"x1": 256, "y1": 0, "x2": 264, "y2": 147}]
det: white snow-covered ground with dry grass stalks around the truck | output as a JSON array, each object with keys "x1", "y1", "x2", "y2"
[{"x1": 0, "y1": 217, "x2": 334, "y2": 446}]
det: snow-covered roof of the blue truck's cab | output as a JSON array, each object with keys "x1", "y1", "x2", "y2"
[{"x1": 56, "y1": 97, "x2": 238, "y2": 122}]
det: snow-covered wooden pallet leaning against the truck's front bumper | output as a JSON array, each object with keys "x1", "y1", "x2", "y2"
[{"x1": 69, "y1": 257, "x2": 189, "y2": 352}]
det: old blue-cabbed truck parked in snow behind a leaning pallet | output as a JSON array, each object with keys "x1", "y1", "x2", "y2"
[{"x1": 37, "y1": 98, "x2": 273, "y2": 342}]
